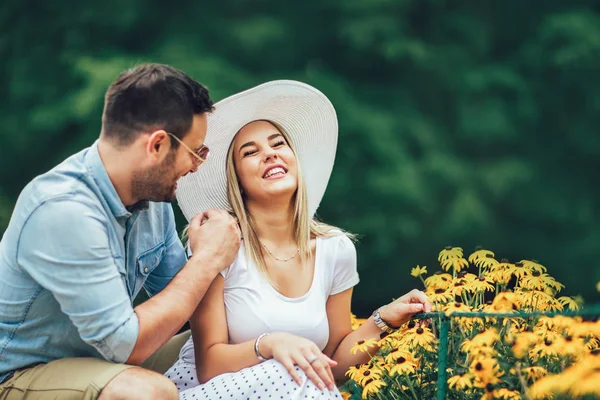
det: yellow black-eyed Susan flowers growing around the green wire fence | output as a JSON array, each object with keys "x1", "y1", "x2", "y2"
[{"x1": 346, "y1": 247, "x2": 600, "y2": 400}]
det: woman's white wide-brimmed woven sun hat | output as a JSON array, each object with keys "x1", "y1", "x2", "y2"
[{"x1": 176, "y1": 80, "x2": 338, "y2": 222}]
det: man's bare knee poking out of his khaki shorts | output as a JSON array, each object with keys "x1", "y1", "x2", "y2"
[{"x1": 98, "y1": 368, "x2": 179, "y2": 400}]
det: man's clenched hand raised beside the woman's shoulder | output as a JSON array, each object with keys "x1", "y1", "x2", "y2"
[{"x1": 188, "y1": 209, "x2": 241, "y2": 275}]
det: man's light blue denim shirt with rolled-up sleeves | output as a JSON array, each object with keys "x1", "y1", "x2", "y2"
[{"x1": 0, "y1": 142, "x2": 186, "y2": 382}]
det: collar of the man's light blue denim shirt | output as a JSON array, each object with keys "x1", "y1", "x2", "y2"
[{"x1": 86, "y1": 140, "x2": 149, "y2": 218}]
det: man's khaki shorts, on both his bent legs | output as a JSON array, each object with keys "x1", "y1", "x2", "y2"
[{"x1": 0, "y1": 331, "x2": 190, "y2": 400}]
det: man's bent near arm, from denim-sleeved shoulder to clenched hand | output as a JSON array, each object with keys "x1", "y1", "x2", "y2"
[{"x1": 17, "y1": 200, "x2": 240, "y2": 364}]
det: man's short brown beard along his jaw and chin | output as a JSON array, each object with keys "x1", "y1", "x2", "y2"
[{"x1": 131, "y1": 150, "x2": 178, "y2": 202}]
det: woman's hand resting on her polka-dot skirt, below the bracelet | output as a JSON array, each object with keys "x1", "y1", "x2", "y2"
[{"x1": 259, "y1": 332, "x2": 337, "y2": 390}]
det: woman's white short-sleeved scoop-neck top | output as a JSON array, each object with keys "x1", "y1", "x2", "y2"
[{"x1": 221, "y1": 234, "x2": 359, "y2": 350}]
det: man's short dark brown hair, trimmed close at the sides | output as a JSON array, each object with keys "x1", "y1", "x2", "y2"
[{"x1": 102, "y1": 64, "x2": 213, "y2": 148}]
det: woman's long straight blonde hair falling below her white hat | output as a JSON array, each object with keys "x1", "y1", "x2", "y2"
[{"x1": 226, "y1": 121, "x2": 355, "y2": 278}]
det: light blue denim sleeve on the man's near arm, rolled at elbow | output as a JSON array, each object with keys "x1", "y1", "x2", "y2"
[{"x1": 17, "y1": 200, "x2": 139, "y2": 363}]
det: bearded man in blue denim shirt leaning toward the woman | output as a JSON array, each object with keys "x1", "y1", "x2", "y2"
[{"x1": 0, "y1": 64, "x2": 241, "y2": 400}]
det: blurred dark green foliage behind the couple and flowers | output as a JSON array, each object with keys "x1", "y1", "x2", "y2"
[{"x1": 0, "y1": 0, "x2": 600, "y2": 315}]
